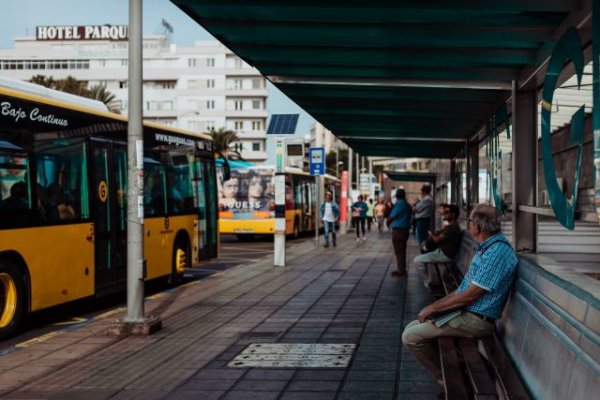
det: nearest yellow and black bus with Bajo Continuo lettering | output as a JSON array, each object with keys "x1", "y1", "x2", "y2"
[{"x1": 0, "y1": 85, "x2": 218, "y2": 338}]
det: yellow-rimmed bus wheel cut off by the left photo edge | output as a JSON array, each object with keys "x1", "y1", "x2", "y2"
[{"x1": 0, "y1": 261, "x2": 25, "y2": 339}]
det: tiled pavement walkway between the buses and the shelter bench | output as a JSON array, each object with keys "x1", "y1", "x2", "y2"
[{"x1": 0, "y1": 232, "x2": 440, "y2": 400}]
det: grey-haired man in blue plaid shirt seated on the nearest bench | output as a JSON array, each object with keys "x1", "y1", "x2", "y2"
[{"x1": 402, "y1": 205, "x2": 517, "y2": 390}]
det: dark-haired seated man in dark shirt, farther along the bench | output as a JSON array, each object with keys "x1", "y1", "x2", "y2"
[{"x1": 414, "y1": 204, "x2": 462, "y2": 263}]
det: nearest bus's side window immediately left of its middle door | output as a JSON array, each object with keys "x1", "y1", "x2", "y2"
[{"x1": 35, "y1": 139, "x2": 89, "y2": 223}]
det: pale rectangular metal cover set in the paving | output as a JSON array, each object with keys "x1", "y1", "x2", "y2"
[{"x1": 227, "y1": 343, "x2": 356, "y2": 368}]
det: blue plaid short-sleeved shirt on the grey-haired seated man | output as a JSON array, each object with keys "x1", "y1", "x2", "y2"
[{"x1": 456, "y1": 233, "x2": 517, "y2": 319}]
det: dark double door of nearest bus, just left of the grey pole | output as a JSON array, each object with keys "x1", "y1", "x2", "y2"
[{"x1": 92, "y1": 141, "x2": 127, "y2": 293}]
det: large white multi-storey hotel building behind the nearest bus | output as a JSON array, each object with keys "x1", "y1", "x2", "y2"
[{"x1": 0, "y1": 26, "x2": 268, "y2": 163}]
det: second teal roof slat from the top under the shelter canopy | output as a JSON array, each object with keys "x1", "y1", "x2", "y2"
[{"x1": 209, "y1": 25, "x2": 552, "y2": 50}]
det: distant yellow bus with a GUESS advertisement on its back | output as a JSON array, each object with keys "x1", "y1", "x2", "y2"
[{"x1": 217, "y1": 166, "x2": 340, "y2": 237}]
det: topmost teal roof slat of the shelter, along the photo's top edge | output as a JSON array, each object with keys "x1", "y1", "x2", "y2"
[{"x1": 171, "y1": 0, "x2": 578, "y2": 25}]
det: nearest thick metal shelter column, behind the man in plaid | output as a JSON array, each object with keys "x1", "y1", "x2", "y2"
[{"x1": 512, "y1": 81, "x2": 538, "y2": 252}]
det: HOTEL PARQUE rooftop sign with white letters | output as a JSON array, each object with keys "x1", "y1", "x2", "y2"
[{"x1": 35, "y1": 25, "x2": 129, "y2": 40}]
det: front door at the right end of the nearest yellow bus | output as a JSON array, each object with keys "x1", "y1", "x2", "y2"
[{"x1": 195, "y1": 157, "x2": 219, "y2": 260}]
